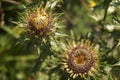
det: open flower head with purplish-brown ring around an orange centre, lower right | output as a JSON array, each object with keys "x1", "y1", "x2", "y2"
[{"x1": 63, "y1": 40, "x2": 97, "y2": 78}]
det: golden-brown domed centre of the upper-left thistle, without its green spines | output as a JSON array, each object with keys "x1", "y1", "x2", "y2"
[{"x1": 26, "y1": 7, "x2": 53, "y2": 37}]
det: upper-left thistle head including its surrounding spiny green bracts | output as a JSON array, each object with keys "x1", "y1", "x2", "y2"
[{"x1": 19, "y1": 0, "x2": 61, "y2": 43}]
